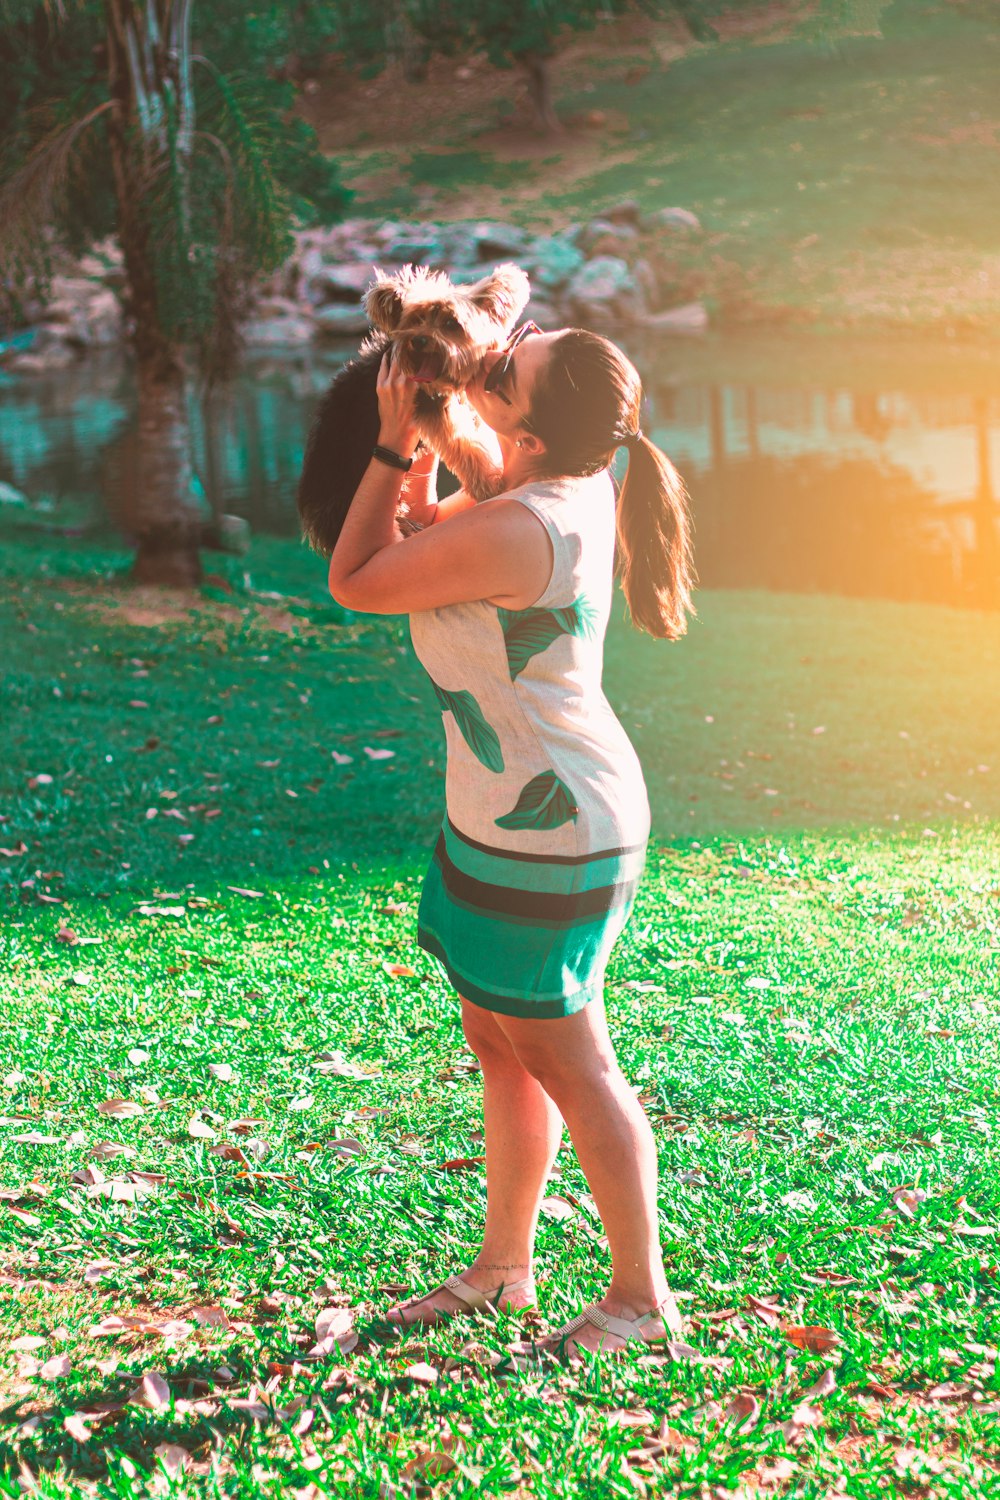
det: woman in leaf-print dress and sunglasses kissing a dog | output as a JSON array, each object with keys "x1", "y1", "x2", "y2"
[{"x1": 330, "y1": 324, "x2": 691, "y2": 1358}]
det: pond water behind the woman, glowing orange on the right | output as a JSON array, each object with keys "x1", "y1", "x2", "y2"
[{"x1": 0, "y1": 336, "x2": 1000, "y2": 609}]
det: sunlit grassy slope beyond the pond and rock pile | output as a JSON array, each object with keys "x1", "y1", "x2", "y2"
[{"x1": 303, "y1": 0, "x2": 1000, "y2": 333}]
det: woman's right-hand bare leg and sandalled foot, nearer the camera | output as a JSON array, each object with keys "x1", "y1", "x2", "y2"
[{"x1": 498, "y1": 999, "x2": 679, "y2": 1347}]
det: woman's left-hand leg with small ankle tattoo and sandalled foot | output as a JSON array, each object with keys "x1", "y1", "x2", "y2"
[{"x1": 387, "y1": 999, "x2": 562, "y2": 1323}]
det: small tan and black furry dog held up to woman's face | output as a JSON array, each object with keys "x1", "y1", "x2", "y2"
[{"x1": 298, "y1": 266, "x2": 531, "y2": 557}]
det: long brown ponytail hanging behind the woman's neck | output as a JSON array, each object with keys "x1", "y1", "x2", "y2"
[{"x1": 615, "y1": 432, "x2": 694, "y2": 641}]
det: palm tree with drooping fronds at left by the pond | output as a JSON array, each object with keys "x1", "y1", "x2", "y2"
[{"x1": 0, "y1": 0, "x2": 346, "y2": 585}]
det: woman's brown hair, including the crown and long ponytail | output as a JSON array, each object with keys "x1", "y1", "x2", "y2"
[{"x1": 528, "y1": 329, "x2": 694, "y2": 641}]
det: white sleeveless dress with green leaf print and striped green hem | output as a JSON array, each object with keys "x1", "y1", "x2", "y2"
[{"x1": 409, "y1": 470, "x2": 649, "y2": 1017}]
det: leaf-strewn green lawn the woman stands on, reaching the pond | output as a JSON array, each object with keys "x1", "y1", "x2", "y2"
[{"x1": 0, "y1": 540, "x2": 1000, "y2": 1500}]
